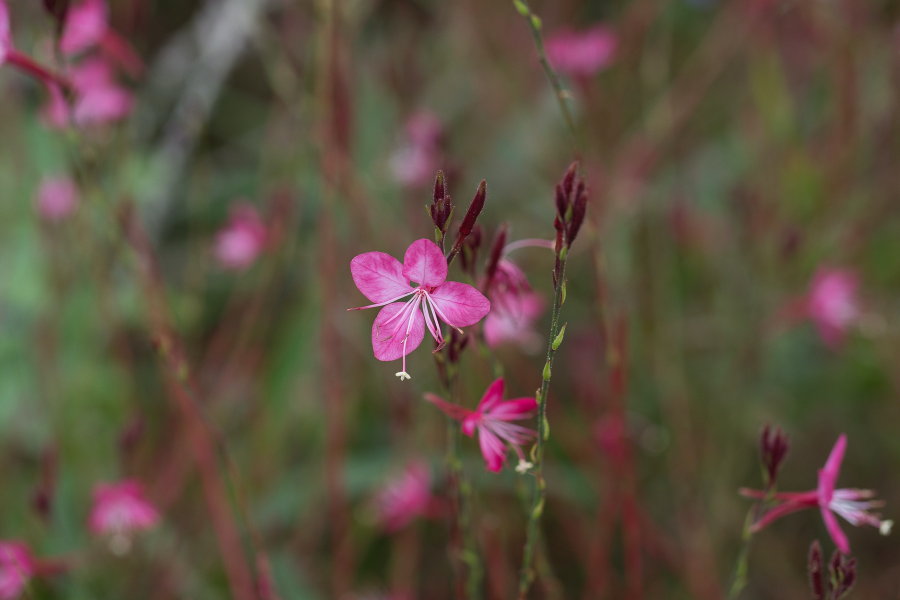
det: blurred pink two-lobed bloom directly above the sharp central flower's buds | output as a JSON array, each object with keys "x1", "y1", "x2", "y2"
[{"x1": 390, "y1": 111, "x2": 441, "y2": 187}]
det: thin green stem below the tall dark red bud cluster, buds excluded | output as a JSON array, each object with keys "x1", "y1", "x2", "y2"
[{"x1": 519, "y1": 255, "x2": 566, "y2": 600}]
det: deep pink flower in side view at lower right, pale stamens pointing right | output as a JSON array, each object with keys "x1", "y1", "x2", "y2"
[{"x1": 741, "y1": 433, "x2": 893, "y2": 554}]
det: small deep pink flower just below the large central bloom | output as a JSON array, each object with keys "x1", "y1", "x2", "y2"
[{"x1": 425, "y1": 377, "x2": 537, "y2": 473}]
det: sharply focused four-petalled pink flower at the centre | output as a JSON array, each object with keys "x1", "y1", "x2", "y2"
[{"x1": 348, "y1": 239, "x2": 491, "y2": 381}]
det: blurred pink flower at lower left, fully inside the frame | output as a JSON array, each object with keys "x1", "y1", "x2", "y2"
[{"x1": 88, "y1": 479, "x2": 159, "y2": 536}]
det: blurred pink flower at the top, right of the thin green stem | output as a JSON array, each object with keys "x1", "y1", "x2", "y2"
[{"x1": 544, "y1": 25, "x2": 619, "y2": 77}]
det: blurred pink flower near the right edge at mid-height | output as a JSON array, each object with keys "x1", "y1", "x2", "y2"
[{"x1": 806, "y1": 269, "x2": 861, "y2": 348}]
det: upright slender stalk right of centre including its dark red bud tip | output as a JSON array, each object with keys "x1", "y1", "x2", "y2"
[{"x1": 518, "y1": 162, "x2": 587, "y2": 600}]
